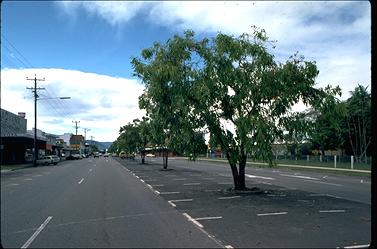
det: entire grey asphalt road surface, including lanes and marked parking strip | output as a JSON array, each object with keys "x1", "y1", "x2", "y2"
[{"x1": 1, "y1": 157, "x2": 371, "y2": 248}]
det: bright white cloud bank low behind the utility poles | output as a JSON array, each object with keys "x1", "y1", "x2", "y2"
[{"x1": 1, "y1": 68, "x2": 144, "y2": 142}]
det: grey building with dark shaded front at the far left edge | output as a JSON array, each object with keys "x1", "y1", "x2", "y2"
[{"x1": 0, "y1": 109, "x2": 46, "y2": 165}]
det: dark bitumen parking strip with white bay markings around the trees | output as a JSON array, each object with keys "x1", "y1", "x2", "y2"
[{"x1": 117, "y1": 159, "x2": 371, "y2": 248}]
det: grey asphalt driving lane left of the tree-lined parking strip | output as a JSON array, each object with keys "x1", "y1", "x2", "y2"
[{"x1": 1, "y1": 158, "x2": 221, "y2": 248}]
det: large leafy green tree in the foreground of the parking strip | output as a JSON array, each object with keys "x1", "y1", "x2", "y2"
[{"x1": 132, "y1": 28, "x2": 338, "y2": 190}]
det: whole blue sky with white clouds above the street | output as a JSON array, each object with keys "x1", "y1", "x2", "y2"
[{"x1": 1, "y1": 1, "x2": 371, "y2": 142}]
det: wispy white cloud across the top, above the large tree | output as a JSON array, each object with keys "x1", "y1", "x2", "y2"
[{"x1": 58, "y1": 1, "x2": 371, "y2": 99}]
